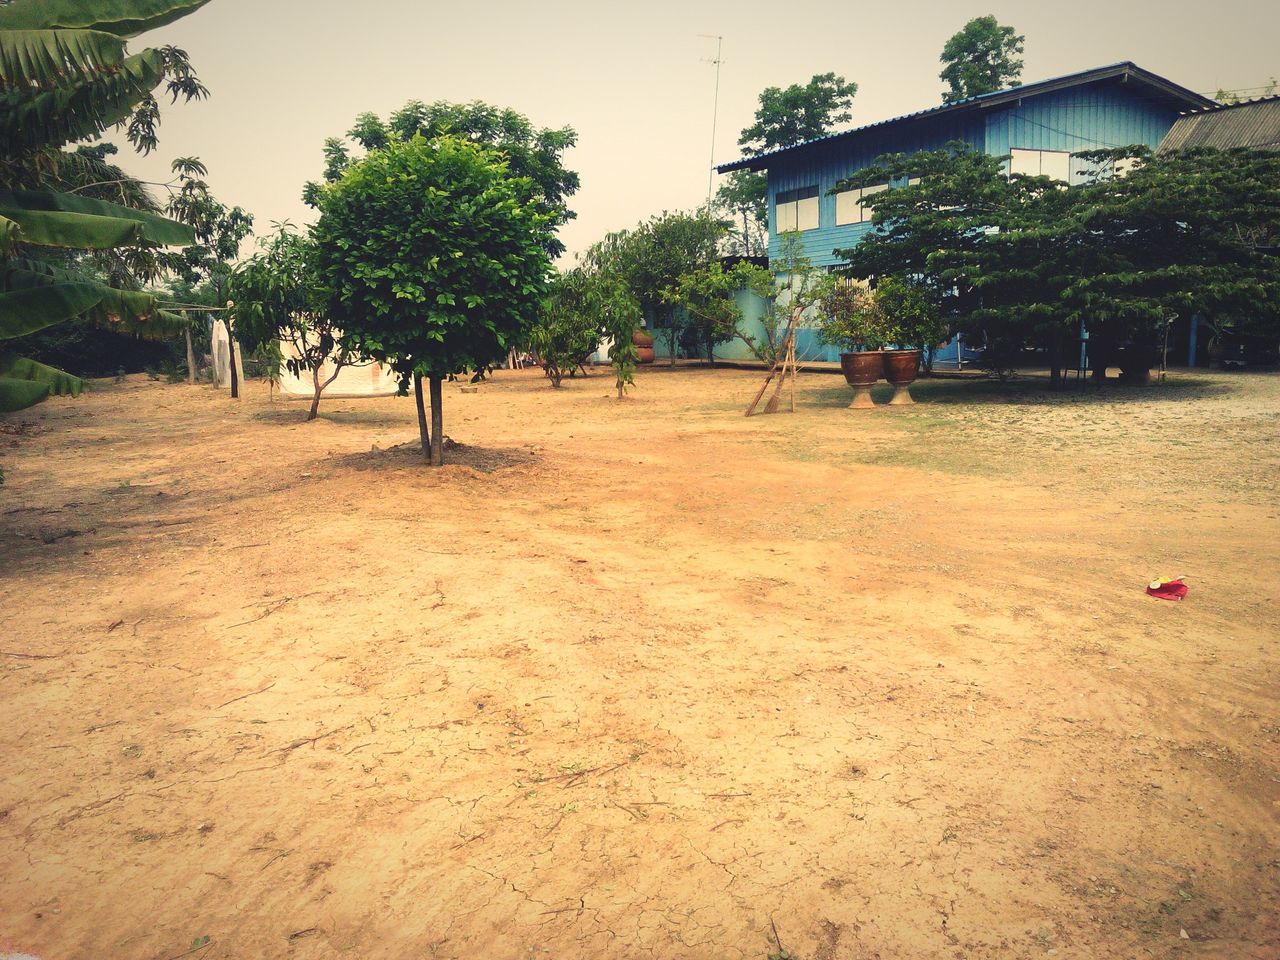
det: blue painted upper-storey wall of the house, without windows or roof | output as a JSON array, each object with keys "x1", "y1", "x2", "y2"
[{"x1": 768, "y1": 76, "x2": 1178, "y2": 268}]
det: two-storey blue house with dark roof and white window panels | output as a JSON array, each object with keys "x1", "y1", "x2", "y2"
[{"x1": 716, "y1": 61, "x2": 1215, "y2": 360}]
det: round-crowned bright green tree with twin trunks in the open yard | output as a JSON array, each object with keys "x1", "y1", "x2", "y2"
[{"x1": 314, "y1": 136, "x2": 553, "y2": 466}]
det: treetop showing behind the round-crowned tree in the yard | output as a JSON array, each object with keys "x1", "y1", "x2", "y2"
[{"x1": 303, "y1": 100, "x2": 580, "y2": 259}]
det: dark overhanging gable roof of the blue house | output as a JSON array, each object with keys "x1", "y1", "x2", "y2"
[{"x1": 716, "y1": 60, "x2": 1216, "y2": 173}]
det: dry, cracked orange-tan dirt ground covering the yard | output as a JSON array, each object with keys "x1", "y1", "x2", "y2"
[{"x1": 0, "y1": 369, "x2": 1280, "y2": 960}]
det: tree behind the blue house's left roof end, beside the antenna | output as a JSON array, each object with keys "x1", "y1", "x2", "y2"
[{"x1": 716, "y1": 73, "x2": 858, "y2": 256}]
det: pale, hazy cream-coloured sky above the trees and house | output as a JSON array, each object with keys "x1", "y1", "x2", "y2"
[{"x1": 127, "y1": 0, "x2": 1280, "y2": 260}]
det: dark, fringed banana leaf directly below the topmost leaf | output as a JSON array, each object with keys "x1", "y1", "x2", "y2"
[{"x1": 0, "y1": 46, "x2": 165, "y2": 156}]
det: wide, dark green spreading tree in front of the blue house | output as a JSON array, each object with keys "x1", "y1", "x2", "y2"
[{"x1": 837, "y1": 146, "x2": 1280, "y2": 381}]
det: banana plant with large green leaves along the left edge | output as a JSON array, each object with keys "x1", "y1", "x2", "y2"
[{"x1": 0, "y1": 0, "x2": 207, "y2": 411}]
